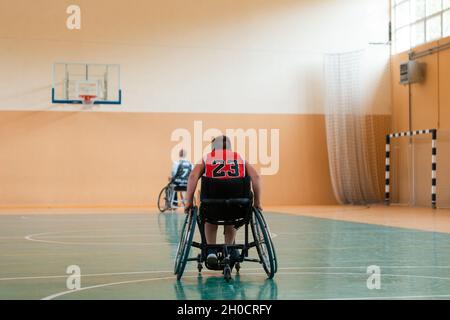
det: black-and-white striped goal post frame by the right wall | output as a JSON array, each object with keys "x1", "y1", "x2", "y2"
[{"x1": 384, "y1": 129, "x2": 437, "y2": 209}]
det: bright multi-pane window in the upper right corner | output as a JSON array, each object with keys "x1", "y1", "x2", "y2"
[{"x1": 391, "y1": 0, "x2": 450, "y2": 53}]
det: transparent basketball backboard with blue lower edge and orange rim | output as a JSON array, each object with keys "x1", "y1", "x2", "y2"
[{"x1": 52, "y1": 62, "x2": 122, "y2": 104}]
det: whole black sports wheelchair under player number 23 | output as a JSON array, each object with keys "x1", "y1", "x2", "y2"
[{"x1": 174, "y1": 177, "x2": 278, "y2": 282}]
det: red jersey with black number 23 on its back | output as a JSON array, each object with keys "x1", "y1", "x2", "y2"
[{"x1": 203, "y1": 150, "x2": 245, "y2": 179}]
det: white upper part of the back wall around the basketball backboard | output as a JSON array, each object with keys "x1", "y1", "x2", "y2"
[{"x1": 0, "y1": 0, "x2": 390, "y2": 114}]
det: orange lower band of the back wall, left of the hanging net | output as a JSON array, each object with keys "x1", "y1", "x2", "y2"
[{"x1": 0, "y1": 111, "x2": 342, "y2": 206}]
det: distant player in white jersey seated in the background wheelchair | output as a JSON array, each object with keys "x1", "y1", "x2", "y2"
[{"x1": 158, "y1": 149, "x2": 193, "y2": 212}]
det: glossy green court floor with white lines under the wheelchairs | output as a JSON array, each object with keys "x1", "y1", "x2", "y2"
[{"x1": 0, "y1": 213, "x2": 450, "y2": 299}]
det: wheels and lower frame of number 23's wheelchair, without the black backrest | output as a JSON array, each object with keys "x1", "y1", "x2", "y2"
[{"x1": 174, "y1": 207, "x2": 278, "y2": 282}]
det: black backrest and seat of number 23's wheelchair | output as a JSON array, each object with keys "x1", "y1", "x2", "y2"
[{"x1": 199, "y1": 177, "x2": 253, "y2": 226}]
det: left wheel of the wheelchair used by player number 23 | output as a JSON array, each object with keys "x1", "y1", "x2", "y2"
[{"x1": 174, "y1": 207, "x2": 197, "y2": 280}]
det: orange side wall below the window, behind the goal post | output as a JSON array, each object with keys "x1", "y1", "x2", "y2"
[{"x1": 391, "y1": 38, "x2": 450, "y2": 207}]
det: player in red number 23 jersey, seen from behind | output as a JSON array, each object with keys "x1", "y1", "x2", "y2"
[{"x1": 185, "y1": 136, "x2": 262, "y2": 268}]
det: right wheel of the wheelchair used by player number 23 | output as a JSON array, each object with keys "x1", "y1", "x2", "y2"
[{"x1": 251, "y1": 209, "x2": 278, "y2": 279}]
